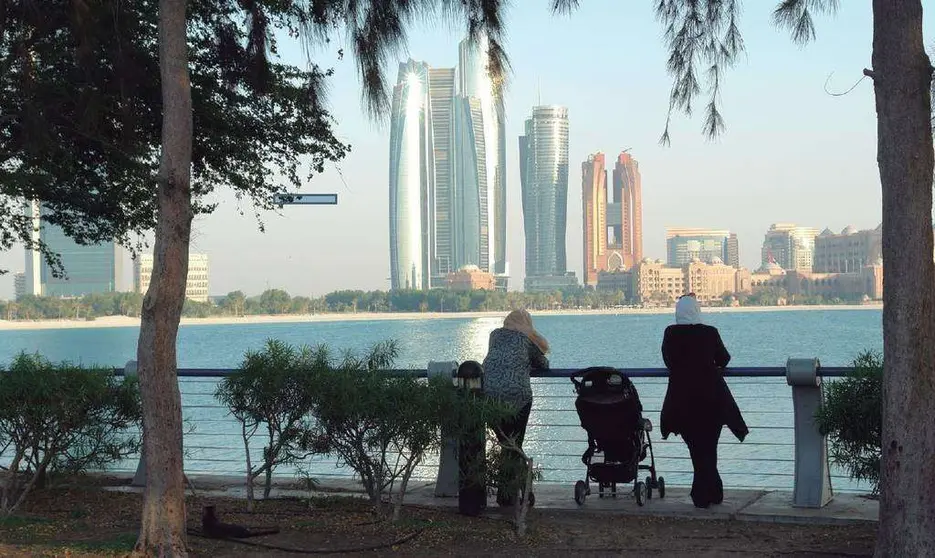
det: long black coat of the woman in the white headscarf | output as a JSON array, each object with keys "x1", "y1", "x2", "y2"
[{"x1": 660, "y1": 324, "x2": 749, "y2": 441}]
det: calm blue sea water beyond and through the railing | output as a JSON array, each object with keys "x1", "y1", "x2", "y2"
[{"x1": 0, "y1": 309, "x2": 883, "y2": 496}]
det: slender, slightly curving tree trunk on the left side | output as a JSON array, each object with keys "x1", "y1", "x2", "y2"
[{"x1": 135, "y1": 0, "x2": 192, "y2": 556}]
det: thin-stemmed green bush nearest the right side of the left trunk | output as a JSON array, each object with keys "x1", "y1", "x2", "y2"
[{"x1": 215, "y1": 339, "x2": 327, "y2": 509}]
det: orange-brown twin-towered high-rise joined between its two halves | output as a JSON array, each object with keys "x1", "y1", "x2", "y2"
[{"x1": 581, "y1": 153, "x2": 643, "y2": 286}]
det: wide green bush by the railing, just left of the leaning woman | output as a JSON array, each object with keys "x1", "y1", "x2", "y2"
[{"x1": 311, "y1": 342, "x2": 512, "y2": 519}]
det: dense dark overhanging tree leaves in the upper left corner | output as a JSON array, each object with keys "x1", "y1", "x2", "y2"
[{"x1": 0, "y1": 0, "x2": 348, "y2": 273}]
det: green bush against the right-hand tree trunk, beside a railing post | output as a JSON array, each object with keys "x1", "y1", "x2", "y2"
[{"x1": 815, "y1": 351, "x2": 883, "y2": 494}]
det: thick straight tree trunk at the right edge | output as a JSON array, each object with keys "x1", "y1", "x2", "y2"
[{"x1": 871, "y1": 0, "x2": 935, "y2": 557}]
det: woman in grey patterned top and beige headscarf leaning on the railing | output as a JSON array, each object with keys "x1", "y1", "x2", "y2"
[{"x1": 484, "y1": 310, "x2": 549, "y2": 506}]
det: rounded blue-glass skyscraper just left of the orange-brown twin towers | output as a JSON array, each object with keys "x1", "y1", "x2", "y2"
[{"x1": 519, "y1": 106, "x2": 568, "y2": 285}]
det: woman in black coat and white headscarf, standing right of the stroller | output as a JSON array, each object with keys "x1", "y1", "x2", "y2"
[{"x1": 660, "y1": 293, "x2": 749, "y2": 508}]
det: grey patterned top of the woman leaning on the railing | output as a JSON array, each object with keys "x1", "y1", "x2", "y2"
[{"x1": 484, "y1": 327, "x2": 549, "y2": 409}]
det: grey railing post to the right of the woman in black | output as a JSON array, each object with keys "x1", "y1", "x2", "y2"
[{"x1": 786, "y1": 358, "x2": 834, "y2": 508}]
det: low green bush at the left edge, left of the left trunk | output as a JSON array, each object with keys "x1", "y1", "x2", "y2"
[{"x1": 0, "y1": 353, "x2": 142, "y2": 514}]
